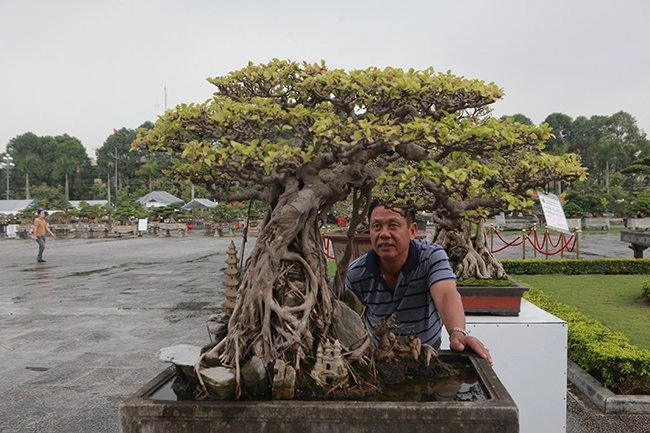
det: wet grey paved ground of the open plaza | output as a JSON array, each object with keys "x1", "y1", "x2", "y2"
[{"x1": 0, "y1": 233, "x2": 650, "y2": 433}]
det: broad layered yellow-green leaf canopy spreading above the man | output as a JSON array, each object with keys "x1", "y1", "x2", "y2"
[{"x1": 135, "y1": 60, "x2": 585, "y2": 224}]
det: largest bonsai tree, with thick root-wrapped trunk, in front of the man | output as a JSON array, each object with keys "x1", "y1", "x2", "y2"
[{"x1": 133, "y1": 60, "x2": 581, "y2": 396}]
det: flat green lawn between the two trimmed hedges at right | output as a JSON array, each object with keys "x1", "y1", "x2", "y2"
[{"x1": 514, "y1": 274, "x2": 650, "y2": 349}]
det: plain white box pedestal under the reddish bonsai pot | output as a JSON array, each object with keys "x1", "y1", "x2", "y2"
[{"x1": 441, "y1": 299, "x2": 567, "y2": 433}]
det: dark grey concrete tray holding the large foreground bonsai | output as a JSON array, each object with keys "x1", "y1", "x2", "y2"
[{"x1": 119, "y1": 353, "x2": 519, "y2": 433}]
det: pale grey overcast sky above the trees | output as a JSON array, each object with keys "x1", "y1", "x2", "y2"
[{"x1": 0, "y1": 0, "x2": 650, "y2": 157}]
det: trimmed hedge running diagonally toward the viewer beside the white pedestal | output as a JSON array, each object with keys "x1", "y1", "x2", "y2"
[{"x1": 524, "y1": 287, "x2": 650, "y2": 394}]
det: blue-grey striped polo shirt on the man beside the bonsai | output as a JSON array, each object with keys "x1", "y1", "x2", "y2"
[{"x1": 345, "y1": 240, "x2": 456, "y2": 346}]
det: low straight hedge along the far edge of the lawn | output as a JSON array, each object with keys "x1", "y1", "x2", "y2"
[{"x1": 500, "y1": 259, "x2": 650, "y2": 275}]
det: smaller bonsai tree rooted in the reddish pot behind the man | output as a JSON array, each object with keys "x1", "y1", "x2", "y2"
[{"x1": 375, "y1": 118, "x2": 586, "y2": 279}]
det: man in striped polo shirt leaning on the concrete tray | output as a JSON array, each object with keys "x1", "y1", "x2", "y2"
[{"x1": 345, "y1": 203, "x2": 492, "y2": 365}]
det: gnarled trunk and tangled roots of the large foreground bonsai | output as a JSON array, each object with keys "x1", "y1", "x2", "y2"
[{"x1": 201, "y1": 179, "x2": 332, "y2": 384}]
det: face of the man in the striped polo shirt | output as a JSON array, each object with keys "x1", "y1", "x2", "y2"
[{"x1": 370, "y1": 206, "x2": 417, "y2": 262}]
